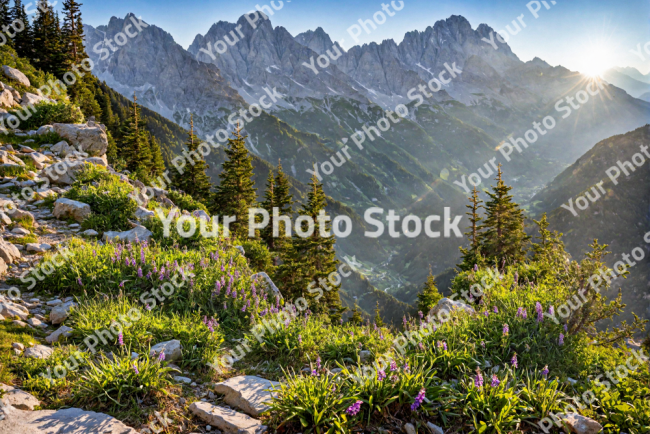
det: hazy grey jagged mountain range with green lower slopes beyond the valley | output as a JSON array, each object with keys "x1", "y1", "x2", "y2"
[{"x1": 84, "y1": 11, "x2": 650, "y2": 312}]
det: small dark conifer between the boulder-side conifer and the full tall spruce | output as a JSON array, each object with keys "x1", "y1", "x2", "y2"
[{"x1": 171, "y1": 116, "x2": 212, "y2": 203}]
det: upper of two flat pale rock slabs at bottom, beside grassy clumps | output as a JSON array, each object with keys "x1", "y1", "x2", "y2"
[{"x1": 214, "y1": 375, "x2": 280, "y2": 417}]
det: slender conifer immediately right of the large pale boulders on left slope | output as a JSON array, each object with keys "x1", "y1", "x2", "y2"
[{"x1": 121, "y1": 92, "x2": 151, "y2": 182}]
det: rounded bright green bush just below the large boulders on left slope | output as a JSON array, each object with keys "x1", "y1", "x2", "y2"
[{"x1": 65, "y1": 170, "x2": 138, "y2": 233}]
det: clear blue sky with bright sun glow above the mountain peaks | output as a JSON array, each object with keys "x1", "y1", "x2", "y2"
[{"x1": 73, "y1": 0, "x2": 650, "y2": 73}]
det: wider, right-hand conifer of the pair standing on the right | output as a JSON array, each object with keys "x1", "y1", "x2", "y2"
[{"x1": 479, "y1": 165, "x2": 530, "y2": 265}]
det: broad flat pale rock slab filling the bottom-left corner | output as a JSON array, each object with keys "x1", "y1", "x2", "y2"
[{"x1": 0, "y1": 407, "x2": 138, "y2": 434}]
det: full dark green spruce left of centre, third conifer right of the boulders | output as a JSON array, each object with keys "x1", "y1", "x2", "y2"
[{"x1": 212, "y1": 127, "x2": 257, "y2": 238}]
